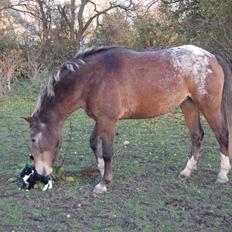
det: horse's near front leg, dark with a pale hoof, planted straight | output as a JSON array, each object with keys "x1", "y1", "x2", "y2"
[{"x1": 94, "y1": 119, "x2": 115, "y2": 194}]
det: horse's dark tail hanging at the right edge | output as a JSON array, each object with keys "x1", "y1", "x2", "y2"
[{"x1": 217, "y1": 56, "x2": 232, "y2": 158}]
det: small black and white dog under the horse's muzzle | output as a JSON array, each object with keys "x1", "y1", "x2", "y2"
[{"x1": 20, "y1": 165, "x2": 52, "y2": 191}]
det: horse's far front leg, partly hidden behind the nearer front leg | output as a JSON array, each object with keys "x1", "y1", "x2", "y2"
[{"x1": 90, "y1": 125, "x2": 105, "y2": 176}]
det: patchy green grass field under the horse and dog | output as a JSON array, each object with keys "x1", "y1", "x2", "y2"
[{"x1": 0, "y1": 81, "x2": 232, "y2": 232}]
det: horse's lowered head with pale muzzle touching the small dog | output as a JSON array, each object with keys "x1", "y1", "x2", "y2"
[{"x1": 24, "y1": 117, "x2": 60, "y2": 176}]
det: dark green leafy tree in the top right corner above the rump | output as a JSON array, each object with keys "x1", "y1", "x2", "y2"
[{"x1": 162, "y1": 0, "x2": 232, "y2": 63}]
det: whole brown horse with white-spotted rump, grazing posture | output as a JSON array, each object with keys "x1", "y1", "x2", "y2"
[{"x1": 25, "y1": 45, "x2": 232, "y2": 193}]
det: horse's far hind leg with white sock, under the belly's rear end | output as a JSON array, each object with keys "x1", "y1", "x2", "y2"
[{"x1": 180, "y1": 98, "x2": 204, "y2": 178}]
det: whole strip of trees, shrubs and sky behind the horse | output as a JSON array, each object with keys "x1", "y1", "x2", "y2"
[{"x1": 0, "y1": 0, "x2": 232, "y2": 95}]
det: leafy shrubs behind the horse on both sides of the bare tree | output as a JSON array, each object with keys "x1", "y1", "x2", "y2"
[{"x1": 0, "y1": 0, "x2": 232, "y2": 96}]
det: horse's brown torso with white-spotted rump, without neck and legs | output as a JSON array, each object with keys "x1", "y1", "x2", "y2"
[{"x1": 86, "y1": 45, "x2": 223, "y2": 119}]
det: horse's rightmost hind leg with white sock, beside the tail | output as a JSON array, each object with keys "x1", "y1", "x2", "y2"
[{"x1": 202, "y1": 107, "x2": 231, "y2": 183}]
